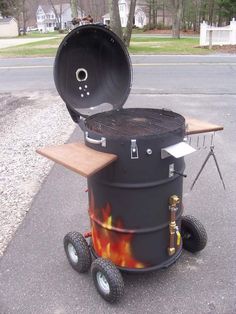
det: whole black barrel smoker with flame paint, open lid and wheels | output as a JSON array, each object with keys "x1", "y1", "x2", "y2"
[{"x1": 54, "y1": 25, "x2": 207, "y2": 302}]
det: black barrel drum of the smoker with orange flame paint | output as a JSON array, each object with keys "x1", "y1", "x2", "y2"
[{"x1": 85, "y1": 108, "x2": 185, "y2": 271}]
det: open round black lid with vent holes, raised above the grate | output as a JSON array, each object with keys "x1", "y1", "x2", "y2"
[{"x1": 54, "y1": 24, "x2": 132, "y2": 120}]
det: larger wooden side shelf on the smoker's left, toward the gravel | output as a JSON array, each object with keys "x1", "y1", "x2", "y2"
[{"x1": 37, "y1": 143, "x2": 117, "y2": 177}]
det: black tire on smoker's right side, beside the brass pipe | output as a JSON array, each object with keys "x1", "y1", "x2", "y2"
[{"x1": 181, "y1": 215, "x2": 207, "y2": 253}]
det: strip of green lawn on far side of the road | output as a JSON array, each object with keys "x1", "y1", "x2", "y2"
[{"x1": 0, "y1": 33, "x2": 211, "y2": 57}]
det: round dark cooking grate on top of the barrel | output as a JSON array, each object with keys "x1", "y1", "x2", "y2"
[{"x1": 86, "y1": 108, "x2": 184, "y2": 136}]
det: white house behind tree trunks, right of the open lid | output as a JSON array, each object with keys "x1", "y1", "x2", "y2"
[{"x1": 103, "y1": 0, "x2": 172, "y2": 28}]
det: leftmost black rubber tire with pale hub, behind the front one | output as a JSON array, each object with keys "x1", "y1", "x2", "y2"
[{"x1": 64, "y1": 231, "x2": 92, "y2": 273}]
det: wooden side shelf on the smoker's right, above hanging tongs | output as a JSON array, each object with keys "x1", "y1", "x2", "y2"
[{"x1": 185, "y1": 117, "x2": 224, "y2": 135}]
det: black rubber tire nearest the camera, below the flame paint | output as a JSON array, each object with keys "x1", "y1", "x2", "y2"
[{"x1": 91, "y1": 258, "x2": 124, "y2": 303}]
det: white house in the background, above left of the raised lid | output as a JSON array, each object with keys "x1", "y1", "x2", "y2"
[{"x1": 36, "y1": 3, "x2": 84, "y2": 33}]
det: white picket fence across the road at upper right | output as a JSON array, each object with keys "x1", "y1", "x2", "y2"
[{"x1": 200, "y1": 18, "x2": 236, "y2": 46}]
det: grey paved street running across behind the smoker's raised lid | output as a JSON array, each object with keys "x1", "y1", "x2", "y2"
[{"x1": 0, "y1": 55, "x2": 236, "y2": 94}]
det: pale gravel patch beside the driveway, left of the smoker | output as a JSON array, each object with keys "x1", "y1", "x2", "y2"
[{"x1": 0, "y1": 91, "x2": 75, "y2": 257}]
